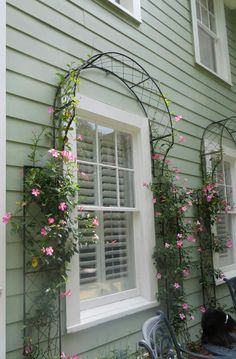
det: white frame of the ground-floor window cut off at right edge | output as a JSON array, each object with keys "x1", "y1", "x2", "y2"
[{"x1": 213, "y1": 146, "x2": 236, "y2": 284}]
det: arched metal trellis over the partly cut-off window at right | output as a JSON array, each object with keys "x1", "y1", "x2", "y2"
[{"x1": 200, "y1": 116, "x2": 236, "y2": 306}]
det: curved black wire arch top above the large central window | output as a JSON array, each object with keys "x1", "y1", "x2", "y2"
[{"x1": 54, "y1": 52, "x2": 174, "y2": 157}]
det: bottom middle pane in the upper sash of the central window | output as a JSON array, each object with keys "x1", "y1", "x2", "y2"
[{"x1": 101, "y1": 166, "x2": 118, "y2": 206}]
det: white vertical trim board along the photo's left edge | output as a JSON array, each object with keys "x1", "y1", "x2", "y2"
[{"x1": 0, "y1": 0, "x2": 6, "y2": 359}]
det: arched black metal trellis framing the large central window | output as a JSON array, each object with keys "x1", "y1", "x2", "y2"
[{"x1": 24, "y1": 52, "x2": 174, "y2": 358}]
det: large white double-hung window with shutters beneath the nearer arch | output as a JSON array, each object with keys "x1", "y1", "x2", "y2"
[{"x1": 67, "y1": 97, "x2": 156, "y2": 331}]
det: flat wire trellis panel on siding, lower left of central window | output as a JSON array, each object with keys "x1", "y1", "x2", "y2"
[{"x1": 23, "y1": 166, "x2": 61, "y2": 359}]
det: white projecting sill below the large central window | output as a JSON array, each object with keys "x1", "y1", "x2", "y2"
[{"x1": 67, "y1": 297, "x2": 158, "y2": 333}]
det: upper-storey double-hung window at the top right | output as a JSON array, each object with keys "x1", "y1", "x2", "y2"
[{"x1": 191, "y1": 0, "x2": 231, "y2": 83}]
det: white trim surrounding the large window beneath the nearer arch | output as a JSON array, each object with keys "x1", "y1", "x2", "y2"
[{"x1": 66, "y1": 95, "x2": 157, "y2": 333}]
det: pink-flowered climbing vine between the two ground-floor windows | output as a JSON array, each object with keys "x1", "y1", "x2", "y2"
[{"x1": 147, "y1": 153, "x2": 232, "y2": 341}]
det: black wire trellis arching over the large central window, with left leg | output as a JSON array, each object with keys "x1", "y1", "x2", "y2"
[{"x1": 23, "y1": 52, "x2": 174, "y2": 359}]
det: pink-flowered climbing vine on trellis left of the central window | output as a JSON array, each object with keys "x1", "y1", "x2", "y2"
[{"x1": 3, "y1": 69, "x2": 95, "y2": 359}]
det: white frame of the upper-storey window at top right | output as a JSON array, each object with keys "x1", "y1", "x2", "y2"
[{"x1": 191, "y1": 0, "x2": 232, "y2": 85}]
